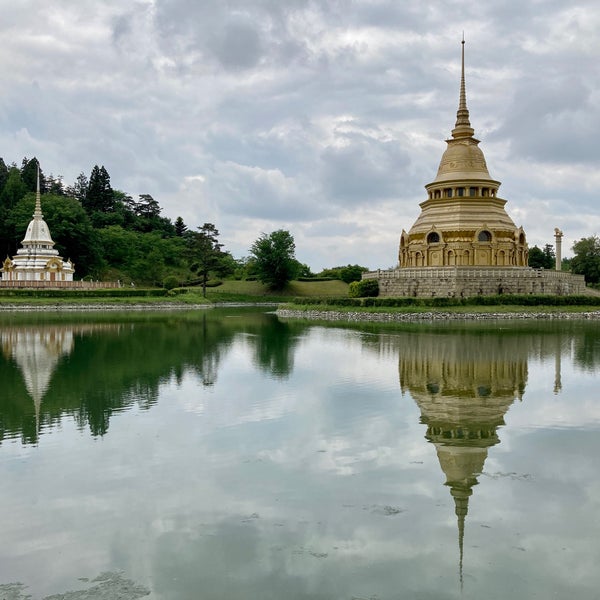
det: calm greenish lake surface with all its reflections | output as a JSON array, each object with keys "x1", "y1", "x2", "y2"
[{"x1": 0, "y1": 311, "x2": 600, "y2": 600}]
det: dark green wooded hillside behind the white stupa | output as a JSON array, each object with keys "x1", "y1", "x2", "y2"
[{"x1": 0, "y1": 157, "x2": 244, "y2": 285}]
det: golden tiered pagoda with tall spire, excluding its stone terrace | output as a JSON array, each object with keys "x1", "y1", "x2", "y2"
[{"x1": 398, "y1": 40, "x2": 528, "y2": 268}]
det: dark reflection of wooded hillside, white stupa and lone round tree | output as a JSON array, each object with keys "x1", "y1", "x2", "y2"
[{"x1": 0, "y1": 310, "x2": 307, "y2": 443}]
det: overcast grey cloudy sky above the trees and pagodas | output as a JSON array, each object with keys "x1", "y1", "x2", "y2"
[{"x1": 0, "y1": 0, "x2": 600, "y2": 271}]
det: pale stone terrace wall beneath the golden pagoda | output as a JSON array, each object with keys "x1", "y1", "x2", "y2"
[{"x1": 363, "y1": 267, "x2": 587, "y2": 298}]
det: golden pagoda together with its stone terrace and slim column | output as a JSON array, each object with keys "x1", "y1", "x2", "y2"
[{"x1": 362, "y1": 39, "x2": 586, "y2": 298}]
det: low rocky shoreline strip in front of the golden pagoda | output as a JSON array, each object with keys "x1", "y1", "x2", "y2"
[{"x1": 276, "y1": 309, "x2": 600, "y2": 323}]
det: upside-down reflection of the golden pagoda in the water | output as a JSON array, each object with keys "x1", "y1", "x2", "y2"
[{"x1": 399, "y1": 332, "x2": 528, "y2": 583}]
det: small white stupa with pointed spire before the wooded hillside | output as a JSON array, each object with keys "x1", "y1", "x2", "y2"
[{"x1": 0, "y1": 167, "x2": 75, "y2": 287}]
